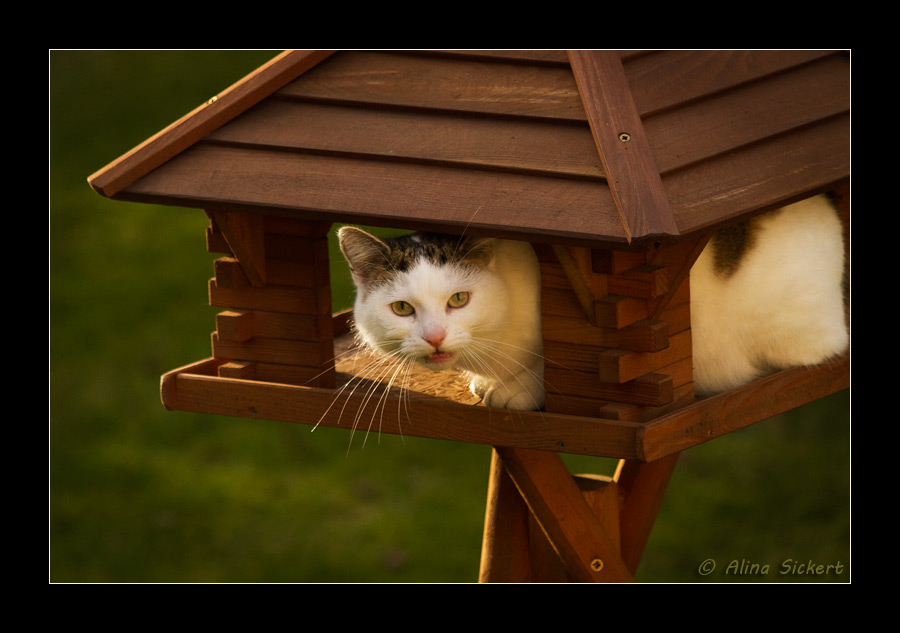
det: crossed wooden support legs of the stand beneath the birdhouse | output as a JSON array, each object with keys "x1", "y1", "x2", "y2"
[{"x1": 479, "y1": 447, "x2": 678, "y2": 582}]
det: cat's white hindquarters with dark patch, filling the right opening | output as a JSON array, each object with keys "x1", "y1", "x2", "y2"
[{"x1": 690, "y1": 195, "x2": 849, "y2": 395}]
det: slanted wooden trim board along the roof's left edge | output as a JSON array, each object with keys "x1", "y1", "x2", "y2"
[{"x1": 88, "y1": 51, "x2": 331, "y2": 198}]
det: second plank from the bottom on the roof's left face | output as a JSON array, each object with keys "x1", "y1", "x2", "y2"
[{"x1": 206, "y1": 100, "x2": 603, "y2": 179}]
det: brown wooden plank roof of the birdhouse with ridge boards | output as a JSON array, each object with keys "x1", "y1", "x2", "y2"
[{"x1": 89, "y1": 50, "x2": 850, "y2": 247}]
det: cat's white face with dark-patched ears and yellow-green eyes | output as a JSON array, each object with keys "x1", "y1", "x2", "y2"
[{"x1": 339, "y1": 228, "x2": 508, "y2": 370}]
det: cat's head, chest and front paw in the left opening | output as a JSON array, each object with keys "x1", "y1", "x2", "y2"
[{"x1": 338, "y1": 226, "x2": 544, "y2": 410}]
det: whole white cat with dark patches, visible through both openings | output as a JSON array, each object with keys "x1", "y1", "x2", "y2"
[{"x1": 339, "y1": 196, "x2": 849, "y2": 409}]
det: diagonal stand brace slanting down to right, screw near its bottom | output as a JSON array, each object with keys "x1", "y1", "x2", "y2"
[{"x1": 496, "y1": 448, "x2": 634, "y2": 582}]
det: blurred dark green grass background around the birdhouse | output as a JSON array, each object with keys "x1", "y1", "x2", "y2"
[{"x1": 49, "y1": 50, "x2": 850, "y2": 583}]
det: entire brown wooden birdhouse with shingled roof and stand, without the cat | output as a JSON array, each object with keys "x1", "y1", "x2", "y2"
[{"x1": 90, "y1": 50, "x2": 850, "y2": 581}]
